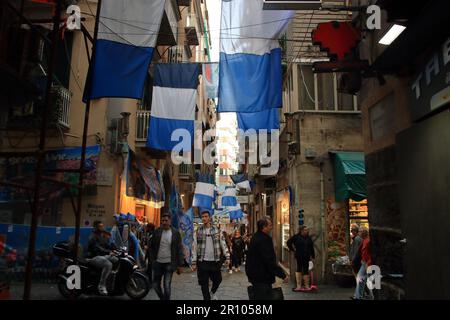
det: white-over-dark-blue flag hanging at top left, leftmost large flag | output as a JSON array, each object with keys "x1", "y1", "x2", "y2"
[{"x1": 83, "y1": 0, "x2": 165, "y2": 101}]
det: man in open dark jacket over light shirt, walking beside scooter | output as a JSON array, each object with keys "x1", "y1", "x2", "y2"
[{"x1": 149, "y1": 213, "x2": 184, "y2": 300}]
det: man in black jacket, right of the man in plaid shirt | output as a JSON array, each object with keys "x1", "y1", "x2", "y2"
[{"x1": 245, "y1": 218, "x2": 289, "y2": 300}]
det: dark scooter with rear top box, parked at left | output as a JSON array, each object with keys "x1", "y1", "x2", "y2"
[{"x1": 53, "y1": 242, "x2": 150, "y2": 300}]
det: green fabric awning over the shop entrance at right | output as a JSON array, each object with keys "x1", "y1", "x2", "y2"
[{"x1": 331, "y1": 151, "x2": 367, "y2": 201}]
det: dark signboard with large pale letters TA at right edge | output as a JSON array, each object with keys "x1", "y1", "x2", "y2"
[{"x1": 411, "y1": 38, "x2": 450, "y2": 121}]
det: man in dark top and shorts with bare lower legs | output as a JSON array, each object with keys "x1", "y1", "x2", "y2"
[{"x1": 287, "y1": 226, "x2": 315, "y2": 291}]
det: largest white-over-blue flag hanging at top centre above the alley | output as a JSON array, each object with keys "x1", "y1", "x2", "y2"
[{"x1": 218, "y1": 0, "x2": 295, "y2": 115}]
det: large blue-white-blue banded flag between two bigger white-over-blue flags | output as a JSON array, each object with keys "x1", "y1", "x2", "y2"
[{"x1": 147, "y1": 63, "x2": 200, "y2": 151}]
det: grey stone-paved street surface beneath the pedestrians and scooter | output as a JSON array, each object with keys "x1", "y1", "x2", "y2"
[{"x1": 11, "y1": 269, "x2": 353, "y2": 300}]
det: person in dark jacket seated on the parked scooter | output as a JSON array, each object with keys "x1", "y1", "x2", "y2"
[{"x1": 87, "y1": 221, "x2": 118, "y2": 295}]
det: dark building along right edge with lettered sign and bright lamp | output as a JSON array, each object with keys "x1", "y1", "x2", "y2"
[{"x1": 355, "y1": 1, "x2": 450, "y2": 299}]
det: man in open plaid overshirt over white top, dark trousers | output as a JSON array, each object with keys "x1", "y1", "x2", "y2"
[{"x1": 192, "y1": 211, "x2": 230, "y2": 300}]
